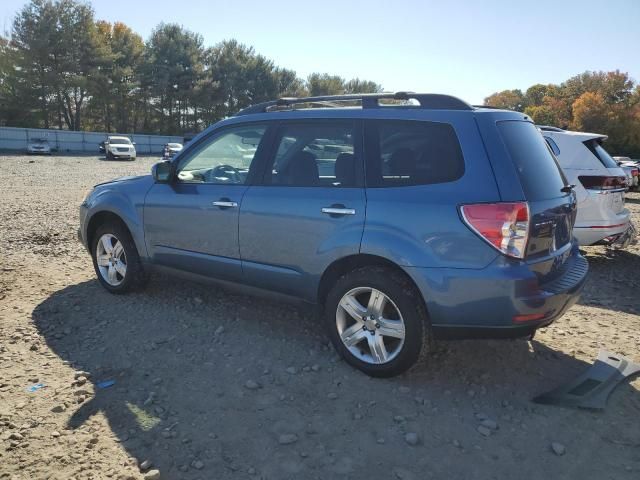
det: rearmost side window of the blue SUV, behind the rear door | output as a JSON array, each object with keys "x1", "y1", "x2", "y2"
[{"x1": 366, "y1": 120, "x2": 464, "y2": 187}]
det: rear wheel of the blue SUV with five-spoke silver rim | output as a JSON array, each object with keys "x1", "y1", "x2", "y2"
[{"x1": 324, "y1": 266, "x2": 431, "y2": 377}]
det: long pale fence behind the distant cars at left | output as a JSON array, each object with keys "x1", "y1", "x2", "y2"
[{"x1": 0, "y1": 127, "x2": 183, "y2": 154}]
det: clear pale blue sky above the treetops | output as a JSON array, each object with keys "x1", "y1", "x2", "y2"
[{"x1": 0, "y1": 0, "x2": 640, "y2": 104}]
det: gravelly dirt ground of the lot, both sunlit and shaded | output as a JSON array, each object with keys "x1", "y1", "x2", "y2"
[{"x1": 0, "y1": 155, "x2": 640, "y2": 480}]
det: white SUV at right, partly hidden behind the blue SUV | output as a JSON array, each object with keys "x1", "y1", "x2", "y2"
[{"x1": 540, "y1": 126, "x2": 636, "y2": 248}]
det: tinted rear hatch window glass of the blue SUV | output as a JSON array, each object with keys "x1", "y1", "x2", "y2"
[{"x1": 498, "y1": 120, "x2": 566, "y2": 201}]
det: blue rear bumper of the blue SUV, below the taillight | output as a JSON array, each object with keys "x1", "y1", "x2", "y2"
[{"x1": 407, "y1": 245, "x2": 589, "y2": 338}]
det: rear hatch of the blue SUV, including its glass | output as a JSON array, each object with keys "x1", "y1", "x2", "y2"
[{"x1": 497, "y1": 120, "x2": 576, "y2": 283}]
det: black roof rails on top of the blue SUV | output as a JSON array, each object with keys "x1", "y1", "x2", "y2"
[{"x1": 236, "y1": 92, "x2": 473, "y2": 116}]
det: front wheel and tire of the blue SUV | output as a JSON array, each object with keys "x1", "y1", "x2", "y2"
[{"x1": 91, "y1": 222, "x2": 146, "y2": 294}]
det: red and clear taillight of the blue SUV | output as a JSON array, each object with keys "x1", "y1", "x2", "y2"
[{"x1": 460, "y1": 202, "x2": 529, "y2": 258}]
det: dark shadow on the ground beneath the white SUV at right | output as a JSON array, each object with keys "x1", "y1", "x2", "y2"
[{"x1": 579, "y1": 249, "x2": 640, "y2": 315}]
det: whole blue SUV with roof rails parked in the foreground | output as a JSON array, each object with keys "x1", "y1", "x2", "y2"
[{"x1": 79, "y1": 93, "x2": 588, "y2": 376}]
